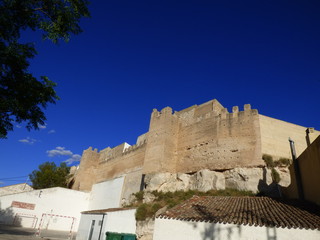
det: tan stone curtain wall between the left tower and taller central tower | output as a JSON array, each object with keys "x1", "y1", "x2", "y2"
[{"x1": 95, "y1": 144, "x2": 146, "y2": 182}]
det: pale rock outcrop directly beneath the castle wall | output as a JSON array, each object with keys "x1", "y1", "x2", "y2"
[{"x1": 145, "y1": 167, "x2": 290, "y2": 194}]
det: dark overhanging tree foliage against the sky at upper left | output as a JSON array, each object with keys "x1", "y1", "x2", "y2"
[{"x1": 0, "y1": 0, "x2": 89, "y2": 138}]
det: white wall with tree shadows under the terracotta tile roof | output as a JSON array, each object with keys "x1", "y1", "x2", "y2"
[{"x1": 153, "y1": 218, "x2": 320, "y2": 240}]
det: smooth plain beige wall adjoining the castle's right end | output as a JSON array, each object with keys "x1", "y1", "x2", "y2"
[{"x1": 259, "y1": 115, "x2": 319, "y2": 159}]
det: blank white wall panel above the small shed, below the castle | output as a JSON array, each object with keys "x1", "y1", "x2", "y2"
[{"x1": 89, "y1": 177, "x2": 124, "y2": 210}]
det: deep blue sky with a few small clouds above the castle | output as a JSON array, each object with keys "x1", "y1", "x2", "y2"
[{"x1": 0, "y1": 0, "x2": 320, "y2": 186}]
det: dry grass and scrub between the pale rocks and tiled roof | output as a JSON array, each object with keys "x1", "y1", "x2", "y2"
[{"x1": 130, "y1": 189, "x2": 254, "y2": 221}]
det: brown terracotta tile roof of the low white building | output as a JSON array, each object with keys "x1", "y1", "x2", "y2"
[{"x1": 157, "y1": 196, "x2": 320, "y2": 230}]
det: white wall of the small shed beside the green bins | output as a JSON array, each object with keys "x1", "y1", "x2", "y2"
[{"x1": 77, "y1": 209, "x2": 136, "y2": 240}]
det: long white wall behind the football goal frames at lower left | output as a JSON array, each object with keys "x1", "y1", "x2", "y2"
[{"x1": 0, "y1": 187, "x2": 89, "y2": 231}]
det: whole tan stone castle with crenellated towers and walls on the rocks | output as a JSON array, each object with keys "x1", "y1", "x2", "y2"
[{"x1": 70, "y1": 99, "x2": 320, "y2": 194}]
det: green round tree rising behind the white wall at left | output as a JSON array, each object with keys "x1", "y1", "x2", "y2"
[{"x1": 29, "y1": 162, "x2": 70, "y2": 189}]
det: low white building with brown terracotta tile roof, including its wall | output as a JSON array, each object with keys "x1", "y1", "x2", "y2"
[{"x1": 153, "y1": 196, "x2": 320, "y2": 240}]
